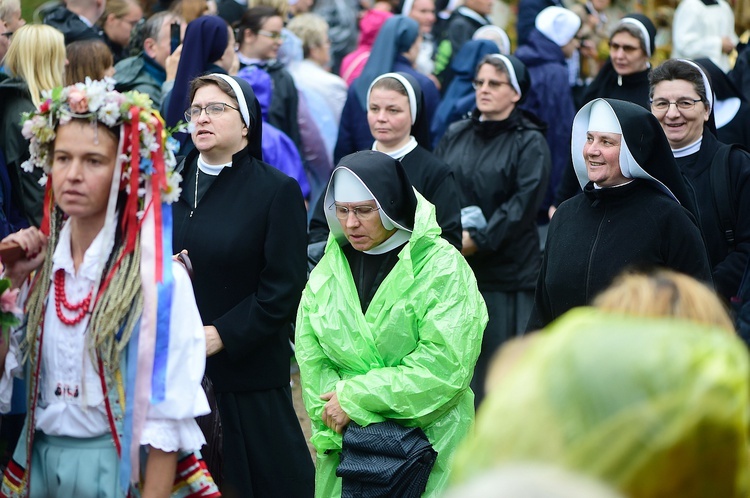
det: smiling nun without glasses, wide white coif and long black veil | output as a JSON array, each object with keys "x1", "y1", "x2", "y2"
[{"x1": 528, "y1": 99, "x2": 712, "y2": 330}]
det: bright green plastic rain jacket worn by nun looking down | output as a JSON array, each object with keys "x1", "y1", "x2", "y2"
[{"x1": 296, "y1": 194, "x2": 487, "y2": 498}]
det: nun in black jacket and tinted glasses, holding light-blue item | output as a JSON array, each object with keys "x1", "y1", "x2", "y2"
[{"x1": 435, "y1": 54, "x2": 550, "y2": 399}]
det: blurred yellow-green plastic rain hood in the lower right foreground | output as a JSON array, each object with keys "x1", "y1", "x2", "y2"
[{"x1": 452, "y1": 308, "x2": 750, "y2": 498}]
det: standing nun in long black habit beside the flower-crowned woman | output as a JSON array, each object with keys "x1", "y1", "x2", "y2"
[{"x1": 173, "y1": 74, "x2": 314, "y2": 498}]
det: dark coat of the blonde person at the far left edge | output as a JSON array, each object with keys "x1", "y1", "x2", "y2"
[{"x1": 0, "y1": 78, "x2": 44, "y2": 226}]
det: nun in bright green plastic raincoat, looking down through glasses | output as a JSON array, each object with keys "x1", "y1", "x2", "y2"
[{"x1": 297, "y1": 151, "x2": 487, "y2": 498}]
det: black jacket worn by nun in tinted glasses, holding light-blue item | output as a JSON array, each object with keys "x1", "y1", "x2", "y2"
[{"x1": 435, "y1": 109, "x2": 550, "y2": 292}]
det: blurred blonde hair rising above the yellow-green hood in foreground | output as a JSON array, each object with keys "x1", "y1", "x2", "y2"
[{"x1": 593, "y1": 268, "x2": 735, "y2": 333}]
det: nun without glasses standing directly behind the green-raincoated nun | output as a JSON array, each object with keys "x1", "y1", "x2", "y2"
[{"x1": 308, "y1": 73, "x2": 461, "y2": 262}]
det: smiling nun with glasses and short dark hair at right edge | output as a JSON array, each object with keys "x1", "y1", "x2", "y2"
[{"x1": 649, "y1": 59, "x2": 750, "y2": 303}]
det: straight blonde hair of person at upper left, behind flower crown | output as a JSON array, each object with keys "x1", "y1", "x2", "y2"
[{"x1": 5, "y1": 24, "x2": 65, "y2": 106}]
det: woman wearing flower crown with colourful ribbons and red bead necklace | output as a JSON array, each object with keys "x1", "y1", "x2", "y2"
[{"x1": 0, "y1": 79, "x2": 219, "y2": 498}]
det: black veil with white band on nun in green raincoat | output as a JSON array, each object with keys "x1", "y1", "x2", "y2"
[{"x1": 324, "y1": 150, "x2": 417, "y2": 246}]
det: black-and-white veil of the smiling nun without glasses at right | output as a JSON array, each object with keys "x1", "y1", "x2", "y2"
[{"x1": 571, "y1": 99, "x2": 697, "y2": 216}]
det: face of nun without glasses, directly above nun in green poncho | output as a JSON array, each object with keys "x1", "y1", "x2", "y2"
[{"x1": 367, "y1": 88, "x2": 411, "y2": 151}]
